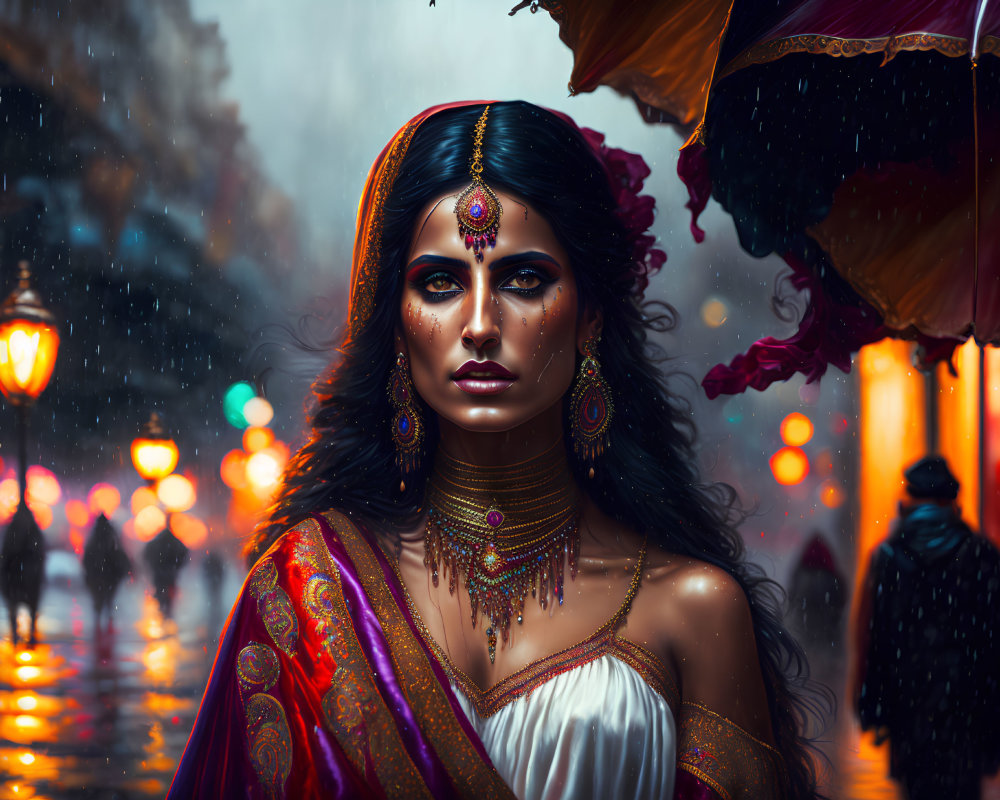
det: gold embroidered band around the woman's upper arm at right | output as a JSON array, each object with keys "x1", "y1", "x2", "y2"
[{"x1": 677, "y1": 701, "x2": 788, "y2": 800}]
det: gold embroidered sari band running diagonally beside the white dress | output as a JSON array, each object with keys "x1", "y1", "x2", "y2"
[{"x1": 321, "y1": 511, "x2": 513, "y2": 798}]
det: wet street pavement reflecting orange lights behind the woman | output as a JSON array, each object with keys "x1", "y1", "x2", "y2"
[{"x1": 0, "y1": 562, "x2": 1000, "y2": 800}]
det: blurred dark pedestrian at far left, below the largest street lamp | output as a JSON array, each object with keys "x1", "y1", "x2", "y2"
[{"x1": 0, "y1": 501, "x2": 45, "y2": 647}]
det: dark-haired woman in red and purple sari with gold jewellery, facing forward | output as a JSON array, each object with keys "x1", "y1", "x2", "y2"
[{"x1": 171, "y1": 102, "x2": 815, "y2": 798}]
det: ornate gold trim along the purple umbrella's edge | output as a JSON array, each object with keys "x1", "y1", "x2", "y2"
[{"x1": 713, "y1": 33, "x2": 972, "y2": 84}]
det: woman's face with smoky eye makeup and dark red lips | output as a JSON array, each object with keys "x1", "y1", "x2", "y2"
[{"x1": 401, "y1": 192, "x2": 589, "y2": 432}]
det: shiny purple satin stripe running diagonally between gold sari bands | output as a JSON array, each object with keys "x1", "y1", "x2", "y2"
[{"x1": 313, "y1": 514, "x2": 452, "y2": 797}]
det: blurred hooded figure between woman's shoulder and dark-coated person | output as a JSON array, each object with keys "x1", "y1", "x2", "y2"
[{"x1": 788, "y1": 531, "x2": 847, "y2": 655}]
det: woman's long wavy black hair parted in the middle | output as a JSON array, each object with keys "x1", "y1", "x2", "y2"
[{"x1": 254, "y1": 102, "x2": 816, "y2": 798}]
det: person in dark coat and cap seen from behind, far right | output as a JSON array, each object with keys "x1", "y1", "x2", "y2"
[{"x1": 854, "y1": 456, "x2": 1000, "y2": 800}]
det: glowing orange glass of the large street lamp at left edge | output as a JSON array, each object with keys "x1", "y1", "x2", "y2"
[{"x1": 0, "y1": 319, "x2": 59, "y2": 405}]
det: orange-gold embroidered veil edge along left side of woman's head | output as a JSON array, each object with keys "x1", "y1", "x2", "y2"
[{"x1": 350, "y1": 119, "x2": 423, "y2": 337}]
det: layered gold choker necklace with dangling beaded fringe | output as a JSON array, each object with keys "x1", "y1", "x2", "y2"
[{"x1": 424, "y1": 439, "x2": 580, "y2": 663}]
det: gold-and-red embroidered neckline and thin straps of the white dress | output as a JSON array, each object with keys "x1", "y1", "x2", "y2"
[{"x1": 387, "y1": 539, "x2": 680, "y2": 718}]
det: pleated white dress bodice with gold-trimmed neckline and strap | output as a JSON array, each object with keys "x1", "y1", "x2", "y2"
[{"x1": 434, "y1": 548, "x2": 678, "y2": 800}]
